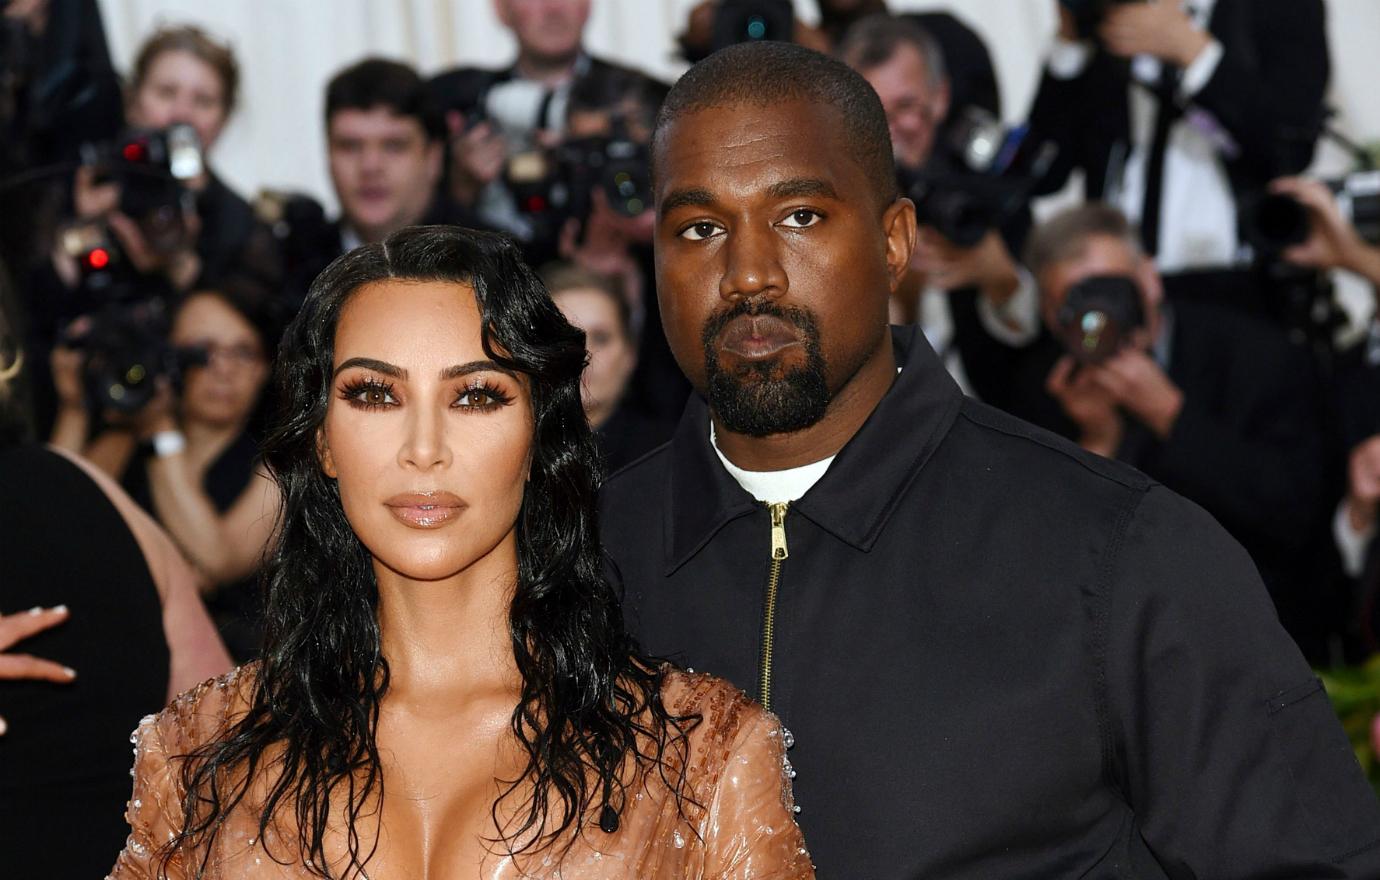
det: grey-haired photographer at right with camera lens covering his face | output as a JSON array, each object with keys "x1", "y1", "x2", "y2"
[{"x1": 1027, "y1": 204, "x2": 1322, "y2": 655}]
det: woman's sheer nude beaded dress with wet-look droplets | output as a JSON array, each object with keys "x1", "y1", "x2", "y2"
[{"x1": 108, "y1": 666, "x2": 814, "y2": 880}]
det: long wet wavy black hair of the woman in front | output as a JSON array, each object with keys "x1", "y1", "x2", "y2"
[{"x1": 160, "y1": 226, "x2": 700, "y2": 879}]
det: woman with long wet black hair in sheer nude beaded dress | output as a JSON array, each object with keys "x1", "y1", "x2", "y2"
[{"x1": 112, "y1": 226, "x2": 814, "y2": 880}]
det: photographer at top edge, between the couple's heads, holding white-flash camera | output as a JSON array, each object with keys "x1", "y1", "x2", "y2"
[{"x1": 431, "y1": 0, "x2": 665, "y2": 262}]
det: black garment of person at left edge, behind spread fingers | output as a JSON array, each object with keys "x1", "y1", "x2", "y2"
[{"x1": 0, "y1": 446, "x2": 168, "y2": 877}]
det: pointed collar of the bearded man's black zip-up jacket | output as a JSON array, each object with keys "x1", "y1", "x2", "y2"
[{"x1": 664, "y1": 326, "x2": 963, "y2": 575}]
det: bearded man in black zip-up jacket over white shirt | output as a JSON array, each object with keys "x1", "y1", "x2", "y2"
[{"x1": 603, "y1": 44, "x2": 1380, "y2": 880}]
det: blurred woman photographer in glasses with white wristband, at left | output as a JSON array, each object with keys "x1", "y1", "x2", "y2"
[{"x1": 51, "y1": 283, "x2": 279, "y2": 662}]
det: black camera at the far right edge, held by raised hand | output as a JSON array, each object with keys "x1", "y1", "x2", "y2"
[{"x1": 1241, "y1": 171, "x2": 1380, "y2": 258}]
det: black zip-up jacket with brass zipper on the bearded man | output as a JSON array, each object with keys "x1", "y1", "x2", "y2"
[{"x1": 603, "y1": 330, "x2": 1380, "y2": 880}]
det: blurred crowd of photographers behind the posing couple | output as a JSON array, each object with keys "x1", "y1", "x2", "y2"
[{"x1": 0, "y1": 0, "x2": 1380, "y2": 871}]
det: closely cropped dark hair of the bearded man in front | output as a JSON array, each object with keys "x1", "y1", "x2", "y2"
[{"x1": 651, "y1": 41, "x2": 900, "y2": 204}]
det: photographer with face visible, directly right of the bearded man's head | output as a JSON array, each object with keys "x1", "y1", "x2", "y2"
[{"x1": 838, "y1": 15, "x2": 1039, "y2": 408}]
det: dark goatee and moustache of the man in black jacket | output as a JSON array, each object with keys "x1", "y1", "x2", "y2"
[{"x1": 701, "y1": 299, "x2": 831, "y2": 437}]
